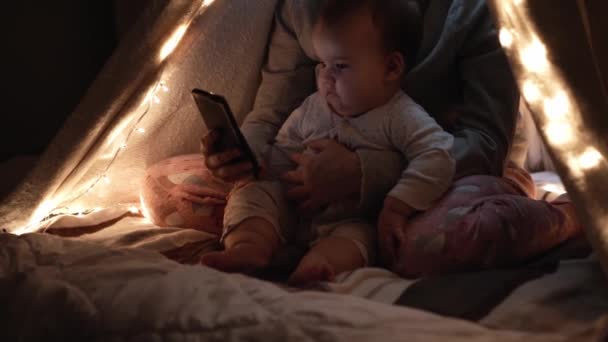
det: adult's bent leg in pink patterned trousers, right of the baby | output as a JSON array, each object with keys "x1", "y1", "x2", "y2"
[{"x1": 392, "y1": 169, "x2": 582, "y2": 277}]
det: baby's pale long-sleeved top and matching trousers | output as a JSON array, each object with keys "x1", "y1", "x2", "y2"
[{"x1": 224, "y1": 91, "x2": 454, "y2": 262}]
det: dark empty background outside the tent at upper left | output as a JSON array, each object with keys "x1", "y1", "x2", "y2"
[{"x1": 0, "y1": 0, "x2": 146, "y2": 163}]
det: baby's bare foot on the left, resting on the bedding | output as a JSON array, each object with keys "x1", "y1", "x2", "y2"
[{"x1": 201, "y1": 243, "x2": 270, "y2": 273}]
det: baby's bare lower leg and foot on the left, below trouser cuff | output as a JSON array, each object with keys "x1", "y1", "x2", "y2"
[{"x1": 201, "y1": 217, "x2": 280, "y2": 273}]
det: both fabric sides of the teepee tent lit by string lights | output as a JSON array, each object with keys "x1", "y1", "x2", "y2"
[{"x1": 0, "y1": 0, "x2": 608, "y2": 276}]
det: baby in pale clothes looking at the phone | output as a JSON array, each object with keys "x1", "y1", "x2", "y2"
[{"x1": 202, "y1": 0, "x2": 454, "y2": 285}]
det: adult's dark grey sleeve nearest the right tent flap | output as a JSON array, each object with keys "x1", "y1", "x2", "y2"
[{"x1": 452, "y1": 6, "x2": 519, "y2": 179}]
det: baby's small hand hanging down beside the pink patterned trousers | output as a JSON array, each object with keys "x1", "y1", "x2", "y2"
[{"x1": 378, "y1": 196, "x2": 414, "y2": 266}]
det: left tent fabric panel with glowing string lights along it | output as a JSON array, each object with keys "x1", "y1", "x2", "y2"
[{"x1": 0, "y1": 0, "x2": 276, "y2": 232}]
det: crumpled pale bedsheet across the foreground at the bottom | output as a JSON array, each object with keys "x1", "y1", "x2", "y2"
[{"x1": 0, "y1": 234, "x2": 594, "y2": 342}]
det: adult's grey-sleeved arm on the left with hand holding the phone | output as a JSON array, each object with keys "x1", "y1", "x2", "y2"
[{"x1": 201, "y1": 1, "x2": 315, "y2": 181}]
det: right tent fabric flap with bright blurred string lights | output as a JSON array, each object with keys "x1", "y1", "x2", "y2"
[{"x1": 488, "y1": 0, "x2": 608, "y2": 274}]
